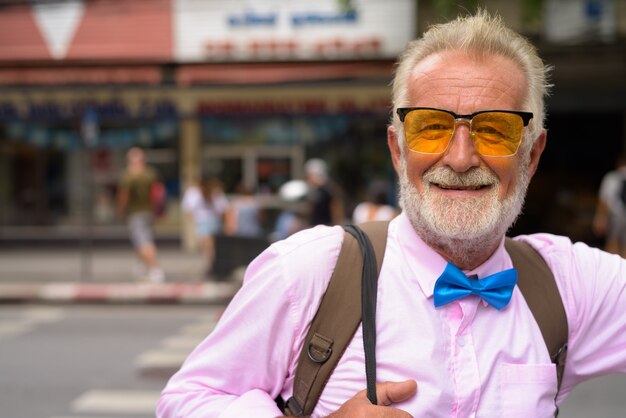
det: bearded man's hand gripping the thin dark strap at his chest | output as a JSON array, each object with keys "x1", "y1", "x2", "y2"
[{"x1": 328, "y1": 380, "x2": 417, "y2": 418}]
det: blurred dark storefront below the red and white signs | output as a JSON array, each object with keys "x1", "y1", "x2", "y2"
[{"x1": 0, "y1": 83, "x2": 391, "y2": 242}]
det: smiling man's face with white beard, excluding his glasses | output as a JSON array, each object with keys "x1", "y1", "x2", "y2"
[{"x1": 388, "y1": 52, "x2": 544, "y2": 242}]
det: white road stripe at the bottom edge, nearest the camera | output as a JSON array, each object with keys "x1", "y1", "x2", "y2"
[{"x1": 71, "y1": 390, "x2": 160, "y2": 414}]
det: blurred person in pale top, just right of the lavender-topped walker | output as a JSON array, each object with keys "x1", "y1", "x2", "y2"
[{"x1": 224, "y1": 184, "x2": 263, "y2": 238}]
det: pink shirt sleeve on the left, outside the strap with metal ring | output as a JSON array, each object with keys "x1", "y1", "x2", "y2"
[{"x1": 157, "y1": 227, "x2": 341, "y2": 418}]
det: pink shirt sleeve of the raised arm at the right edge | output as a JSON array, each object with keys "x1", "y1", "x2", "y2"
[{"x1": 528, "y1": 235, "x2": 626, "y2": 399}]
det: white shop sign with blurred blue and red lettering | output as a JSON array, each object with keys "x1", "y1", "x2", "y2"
[{"x1": 174, "y1": 0, "x2": 417, "y2": 62}]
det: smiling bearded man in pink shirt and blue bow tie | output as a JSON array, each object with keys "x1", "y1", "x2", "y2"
[{"x1": 157, "y1": 10, "x2": 626, "y2": 418}]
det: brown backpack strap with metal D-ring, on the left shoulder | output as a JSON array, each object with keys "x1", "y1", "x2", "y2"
[{"x1": 284, "y1": 221, "x2": 389, "y2": 416}]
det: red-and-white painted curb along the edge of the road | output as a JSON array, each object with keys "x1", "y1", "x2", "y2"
[{"x1": 0, "y1": 282, "x2": 239, "y2": 305}]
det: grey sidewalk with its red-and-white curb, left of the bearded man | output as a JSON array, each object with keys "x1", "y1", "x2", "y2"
[{"x1": 0, "y1": 246, "x2": 242, "y2": 304}]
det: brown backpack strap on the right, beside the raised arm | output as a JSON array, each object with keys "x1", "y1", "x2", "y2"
[{"x1": 504, "y1": 238, "x2": 569, "y2": 388}]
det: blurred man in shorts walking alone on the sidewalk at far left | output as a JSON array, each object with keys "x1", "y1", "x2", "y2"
[{"x1": 117, "y1": 147, "x2": 165, "y2": 282}]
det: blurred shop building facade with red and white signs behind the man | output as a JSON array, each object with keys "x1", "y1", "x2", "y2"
[{"x1": 0, "y1": 0, "x2": 626, "y2": 248}]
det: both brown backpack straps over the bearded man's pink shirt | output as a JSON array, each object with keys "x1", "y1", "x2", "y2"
[{"x1": 284, "y1": 230, "x2": 568, "y2": 416}]
